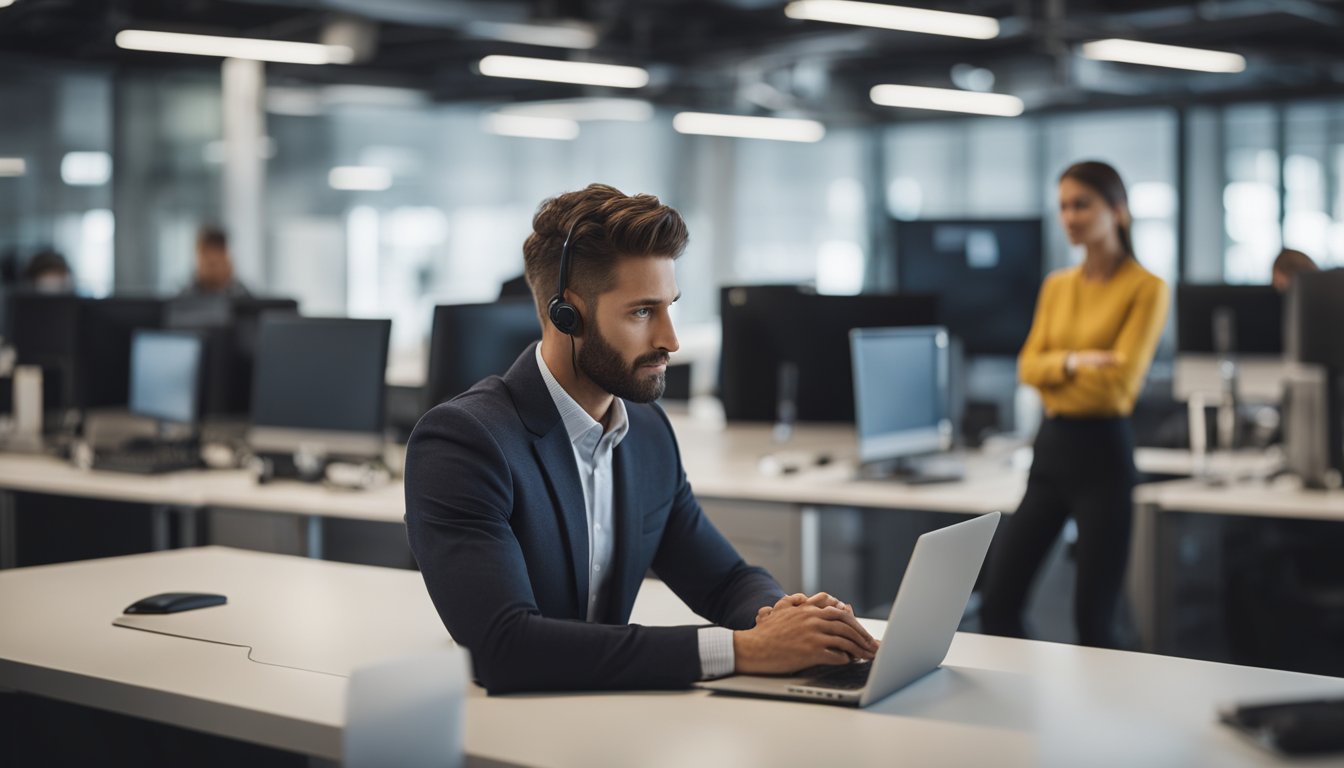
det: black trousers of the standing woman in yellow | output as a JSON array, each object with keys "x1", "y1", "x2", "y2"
[{"x1": 980, "y1": 418, "x2": 1137, "y2": 648}]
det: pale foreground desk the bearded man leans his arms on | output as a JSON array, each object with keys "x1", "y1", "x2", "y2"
[{"x1": 0, "y1": 547, "x2": 1344, "y2": 768}]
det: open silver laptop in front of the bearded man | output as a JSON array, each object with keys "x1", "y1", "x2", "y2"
[{"x1": 696, "y1": 512, "x2": 1000, "y2": 706}]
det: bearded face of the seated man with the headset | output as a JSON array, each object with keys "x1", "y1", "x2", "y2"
[{"x1": 578, "y1": 257, "x2": 681, "y2": 402}]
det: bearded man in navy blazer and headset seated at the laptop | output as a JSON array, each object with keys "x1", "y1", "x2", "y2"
[{"x1": 406, "y1": 184, "x2": 878, "y2": 693}]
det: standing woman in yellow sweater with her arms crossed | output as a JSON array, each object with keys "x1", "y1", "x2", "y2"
[{"x1": 981, "y1": 161, "x2": 1169, "y2": 647}]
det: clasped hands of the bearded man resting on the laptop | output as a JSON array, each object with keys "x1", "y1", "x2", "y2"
[{"x1": 732, "y1": 592, "x2": 878, "y2": 674}]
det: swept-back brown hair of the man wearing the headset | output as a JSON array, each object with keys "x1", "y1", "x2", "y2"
[{"x1": 523, "y1": 184, "x2": 689, "y2": 325}]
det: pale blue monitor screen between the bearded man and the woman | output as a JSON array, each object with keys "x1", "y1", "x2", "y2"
[{"x1": 849, "y1": 325, "x2": 952, "y2": 463}]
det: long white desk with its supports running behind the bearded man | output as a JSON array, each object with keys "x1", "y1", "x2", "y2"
[{"x1": 0, "y1": 433, "x2": 1231, "y2": 593}]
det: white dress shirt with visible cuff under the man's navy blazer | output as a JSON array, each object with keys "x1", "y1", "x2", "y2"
[{"x1": 536, "y1": 344, "x2": 734, "y2": 678}]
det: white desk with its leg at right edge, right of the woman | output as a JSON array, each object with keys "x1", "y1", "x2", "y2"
[{"x1": 1130, "y1": 477, "x2": 1344, "y2": 648}]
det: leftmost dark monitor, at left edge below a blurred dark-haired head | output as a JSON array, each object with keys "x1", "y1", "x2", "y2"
[{"x1": 9, "y1": 291, "x2": 81, "y2": 425}]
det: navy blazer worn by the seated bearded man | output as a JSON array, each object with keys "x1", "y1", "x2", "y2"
[{"x1": 406, "y1": 344, "x2": 784, "y2": 693}]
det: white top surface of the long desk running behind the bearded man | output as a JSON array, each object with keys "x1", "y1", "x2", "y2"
[{"x1": 0, "y1": 433, "x2": 1295, "y2": 523}]
